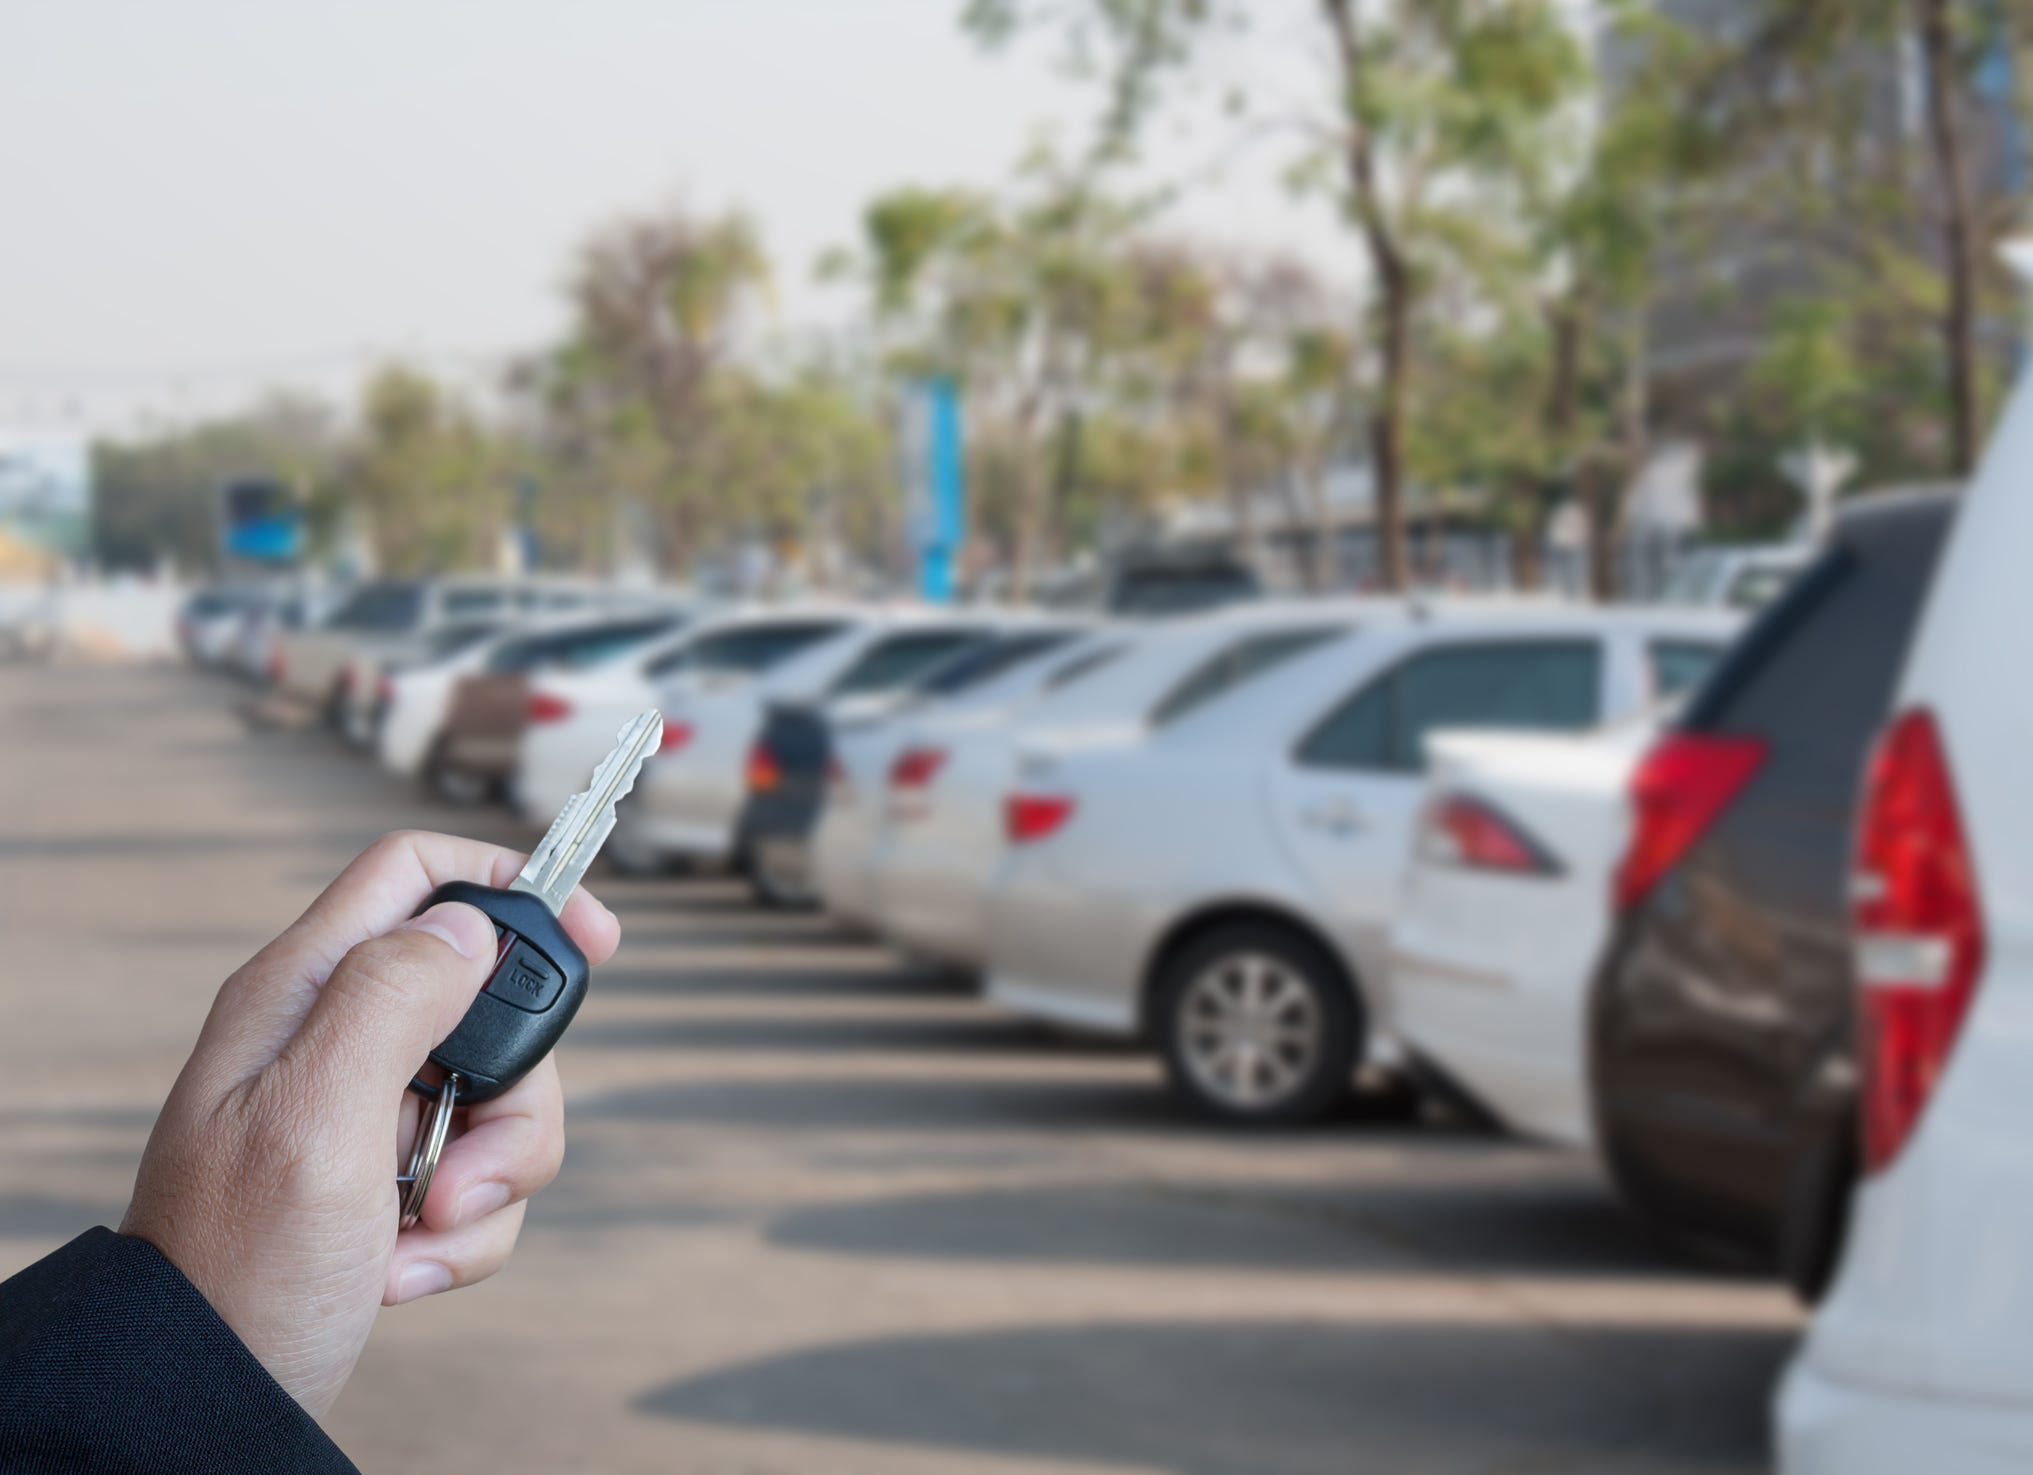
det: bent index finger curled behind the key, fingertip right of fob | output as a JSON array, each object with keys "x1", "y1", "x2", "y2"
[{"x1": 205, "y1": 829, "x2": 620, "y2": 1056}]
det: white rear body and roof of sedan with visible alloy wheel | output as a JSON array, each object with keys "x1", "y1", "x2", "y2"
[{"x1": 988, "y1": 605, "x2": 1738, "y2": 1063}]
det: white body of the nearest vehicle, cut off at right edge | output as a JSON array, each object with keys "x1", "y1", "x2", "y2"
[{"x1": 1779, "y1": 376, "x2": 2033, "y2": 1475}]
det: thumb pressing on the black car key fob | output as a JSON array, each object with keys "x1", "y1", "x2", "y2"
[{"x1": 283, "y1": 902, "x2": 498, "y2": 1099}]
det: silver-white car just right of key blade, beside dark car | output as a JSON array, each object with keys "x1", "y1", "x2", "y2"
[{"x1": 608, "y1": 605, "x2": 992, "y2": 886}]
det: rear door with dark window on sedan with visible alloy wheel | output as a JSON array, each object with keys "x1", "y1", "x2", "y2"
[{"x1": 1271, "y1": 634, "x2": 1608, "y2": 989}]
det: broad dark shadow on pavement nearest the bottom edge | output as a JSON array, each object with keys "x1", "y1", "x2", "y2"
[{"x1": 636, "y1": 1319, "x2": 1791, "y2": 1475}]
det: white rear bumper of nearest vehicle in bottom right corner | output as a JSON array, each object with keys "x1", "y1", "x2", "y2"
[{"x1": 1779, "y1": 1355, "x2": 2033, "y2": 1475}]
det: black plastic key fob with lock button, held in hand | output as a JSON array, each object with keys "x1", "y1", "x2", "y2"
[{"x1": 417, "y1": 882, "x2": 592, "y2": 1105}]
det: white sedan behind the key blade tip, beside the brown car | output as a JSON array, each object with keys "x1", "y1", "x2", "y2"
[{"x1": 510, "y1": 603, "x2": 862, "y2": 872}]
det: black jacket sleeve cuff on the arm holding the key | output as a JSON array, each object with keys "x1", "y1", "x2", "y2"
[{"x1": 0, "y1": 1229, "x2": 360, "y2": 1475}]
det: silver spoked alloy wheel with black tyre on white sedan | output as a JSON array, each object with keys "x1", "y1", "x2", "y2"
[{"x1": 1153, "y1": 922, "x2": 1364, "y2": 1126}]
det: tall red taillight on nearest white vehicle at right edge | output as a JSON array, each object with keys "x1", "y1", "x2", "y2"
[{"x1": 1852, "y1": 709, "x2": 1984, "y2": 1172}]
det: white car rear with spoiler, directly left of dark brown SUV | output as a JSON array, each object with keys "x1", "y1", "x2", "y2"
[{"x1": 1389, "y1": 711, "x2": 1675, "y2": 1146}]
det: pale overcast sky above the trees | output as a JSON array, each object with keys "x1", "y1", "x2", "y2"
[{"x1": 0, "y1": 0, "x2": 1354, "y2": 431}]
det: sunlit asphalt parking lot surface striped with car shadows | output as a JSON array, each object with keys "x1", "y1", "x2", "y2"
[{"x1": 0, "y1": 666, "x2": 1799, "y2": 1475}]
